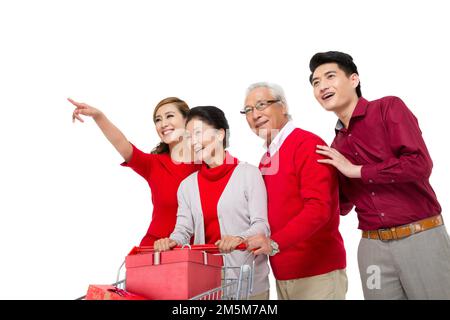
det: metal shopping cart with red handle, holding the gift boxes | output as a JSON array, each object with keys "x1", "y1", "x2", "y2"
[{"x1": 77, "y1": 244, "x2": 255, "y2": 300}]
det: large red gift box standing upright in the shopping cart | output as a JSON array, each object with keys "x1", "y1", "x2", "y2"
[{"x1": 125, "y1": 247, "x2": 223, "y2": 300}]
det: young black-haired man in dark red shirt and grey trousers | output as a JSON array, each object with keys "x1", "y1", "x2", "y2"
[{"x1": 310, "y1": 51, "x2": 450, "y2": 299}]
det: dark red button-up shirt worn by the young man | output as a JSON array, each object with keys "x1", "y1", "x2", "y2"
[{"x1": 332, "y1": 97, "x2": 441, "y2": 230}]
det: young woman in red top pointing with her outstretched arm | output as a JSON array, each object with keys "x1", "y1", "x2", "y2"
[{"x1": 68, "y1": 97, "x2": 200, "y2": 246}]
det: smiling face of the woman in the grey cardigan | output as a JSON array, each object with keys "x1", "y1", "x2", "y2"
[{"x1": 186, "y1": 118, "x2": 225, "y2": 164}]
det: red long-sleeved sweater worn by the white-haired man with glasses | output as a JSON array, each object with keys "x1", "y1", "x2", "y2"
[{"x1": 260, "y1": 128, "x2": 346, "y2": 280}]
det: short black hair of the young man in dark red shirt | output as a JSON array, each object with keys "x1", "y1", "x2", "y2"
[{"x1": 309, "y1": 51, "x2": 361, "y2": 98}]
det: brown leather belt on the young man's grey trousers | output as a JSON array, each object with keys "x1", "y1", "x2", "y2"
[{"x1": 363, "y1": 215, "x2": 444, "y2": 241}]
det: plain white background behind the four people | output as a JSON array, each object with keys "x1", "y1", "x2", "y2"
[{"x1": 0, "y1": 0, "x2": 450, "y2": 299}]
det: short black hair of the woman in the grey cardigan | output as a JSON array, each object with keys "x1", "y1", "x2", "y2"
[{"x1": 186, "y1": 106, "x2": 230, "y2": 149}]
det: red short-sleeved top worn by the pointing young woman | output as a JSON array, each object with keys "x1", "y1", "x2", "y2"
[{"x1": 122, "y1": 145, "x2": 200, "y2": 246}]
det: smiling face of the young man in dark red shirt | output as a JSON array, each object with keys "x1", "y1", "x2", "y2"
[{"x1": 311, "y1": 63, "x2": 359, "y2": 113}]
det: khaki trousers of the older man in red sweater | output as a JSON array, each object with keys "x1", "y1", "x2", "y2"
[{"x1": 277, "y1": 270, "x2": 348, "y2": 300}]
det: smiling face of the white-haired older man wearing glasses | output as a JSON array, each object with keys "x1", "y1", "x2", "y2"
[{"x1": 245, "y1": 87, "x2": 288, "y2": 143}]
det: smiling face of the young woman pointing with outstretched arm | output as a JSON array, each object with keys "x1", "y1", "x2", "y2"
[{"x1": 154, "y1": 103, "x2": 186, "y2": 145}]
